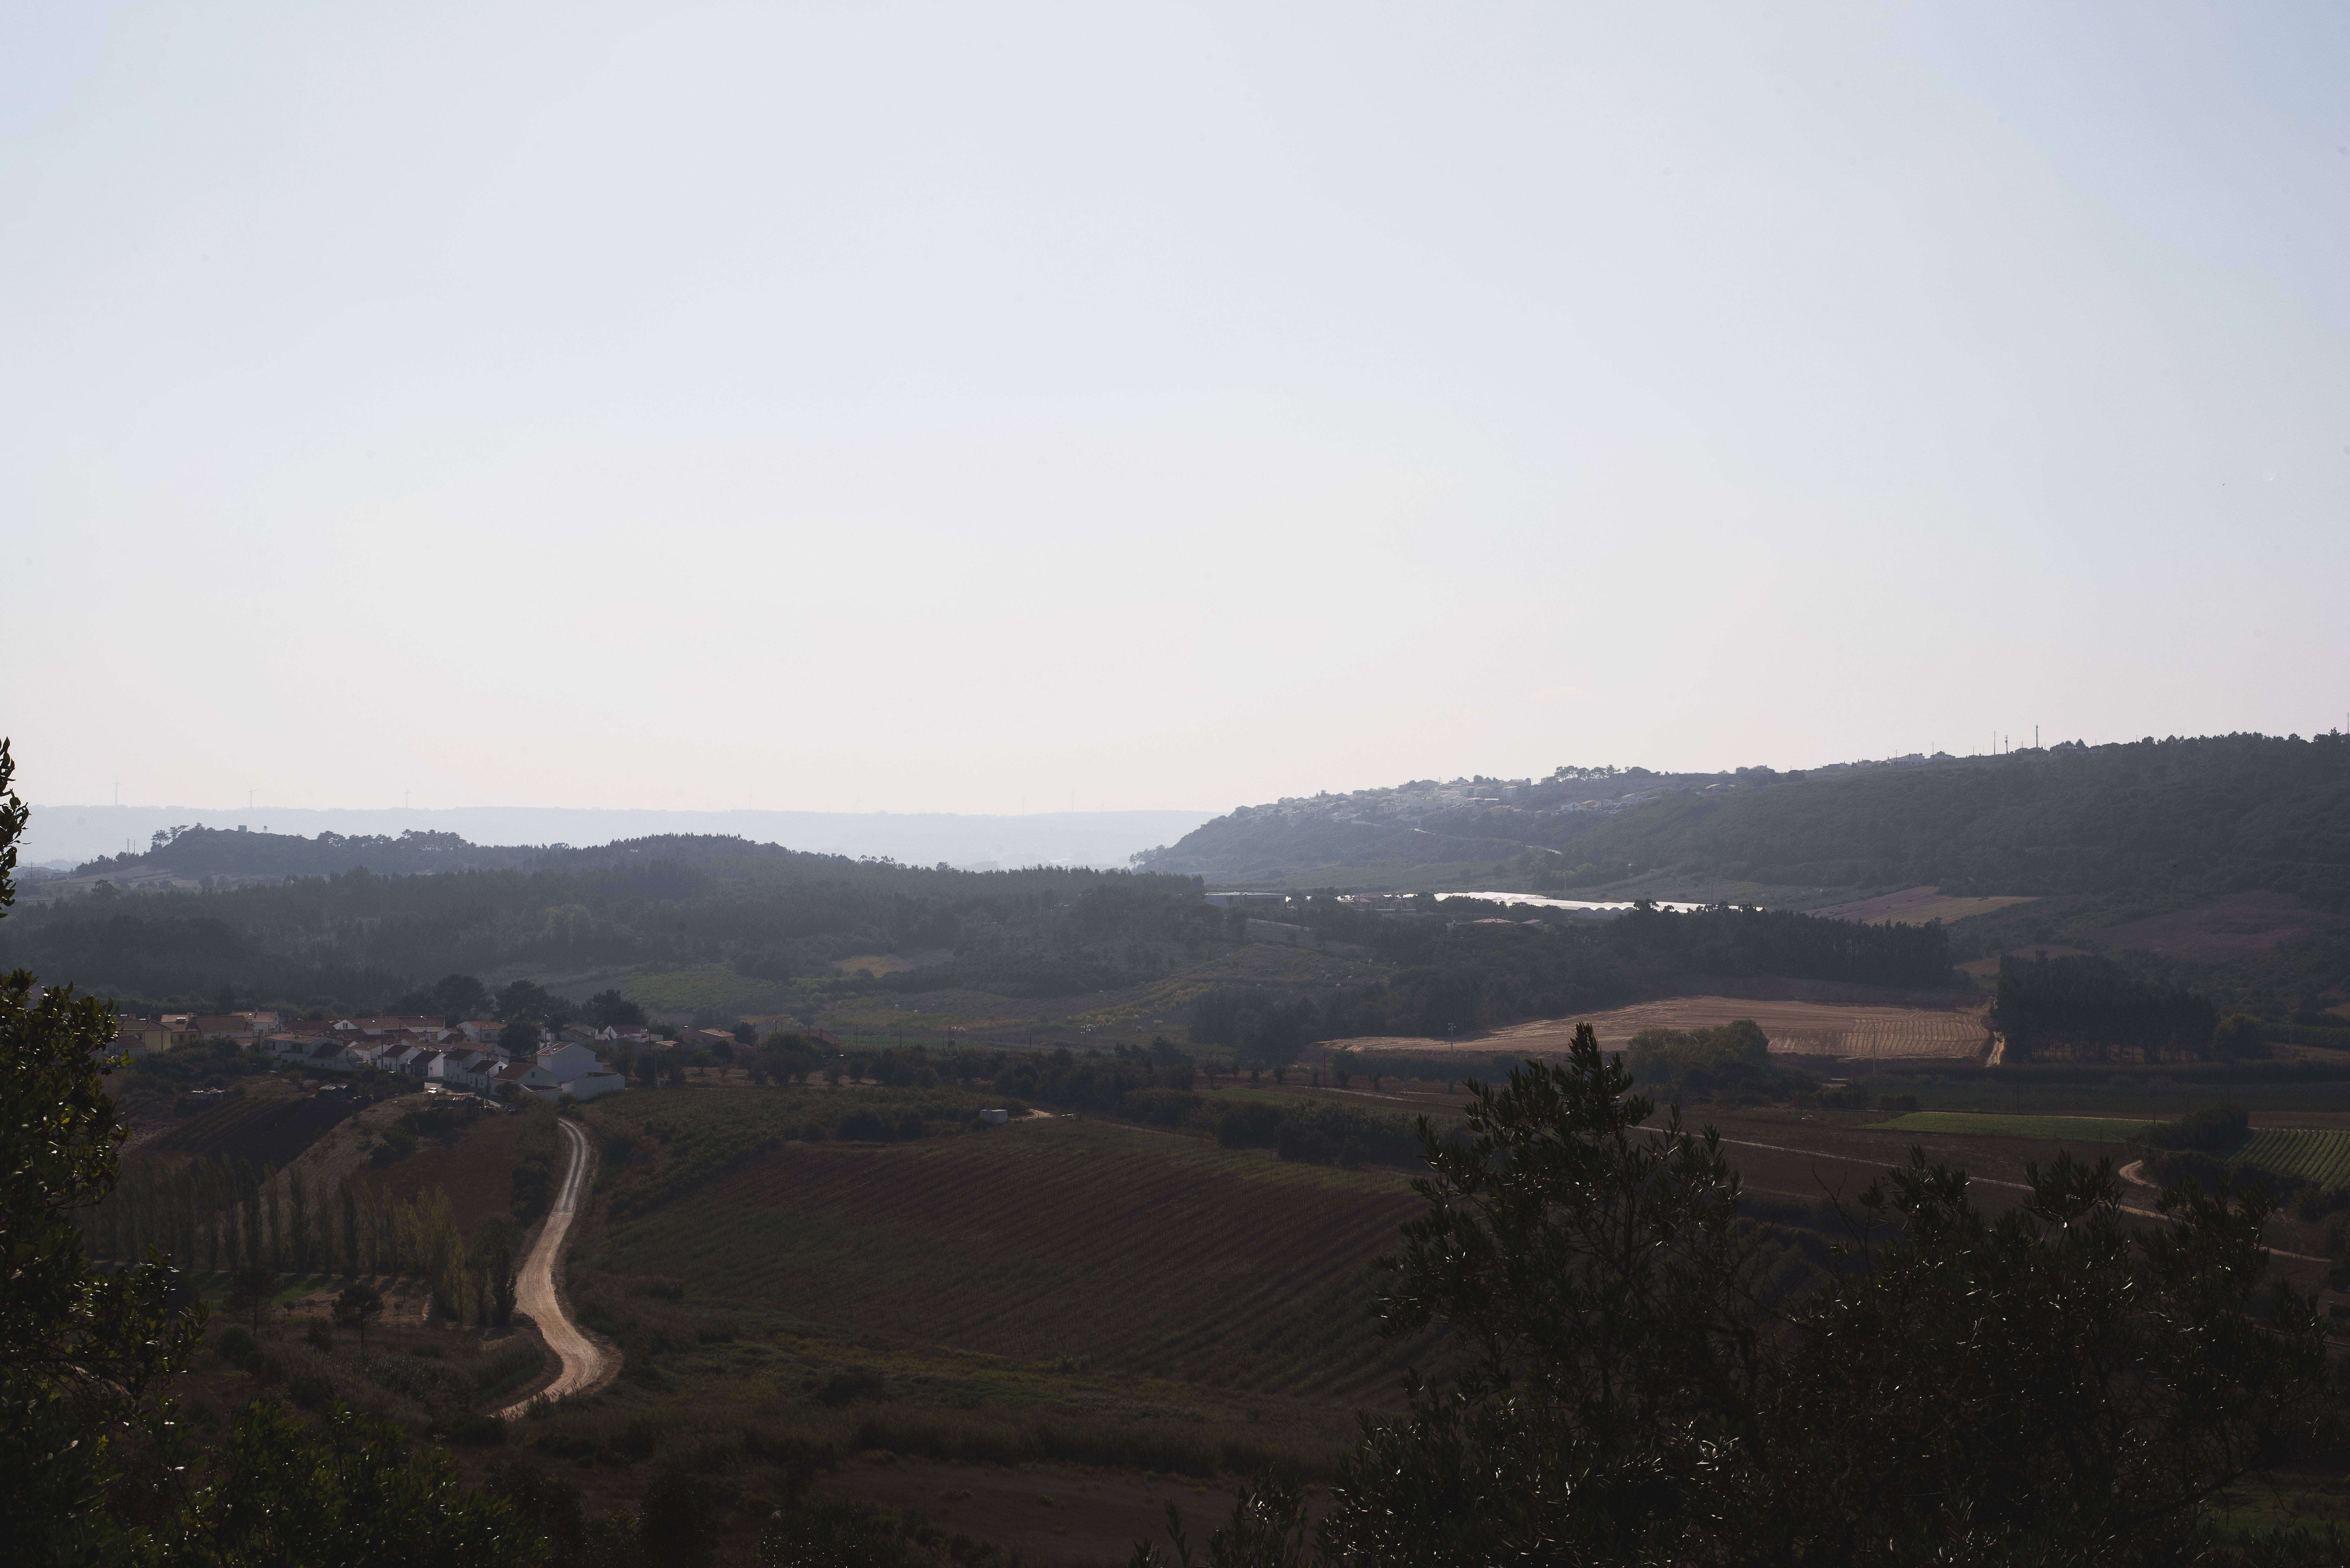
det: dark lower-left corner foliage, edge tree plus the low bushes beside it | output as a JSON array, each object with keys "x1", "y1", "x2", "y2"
[{"x1": 0, "y1": 741, "x2": 548, "y2": 1568}]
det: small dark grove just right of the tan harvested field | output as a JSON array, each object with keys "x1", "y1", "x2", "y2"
[{"x1": 1993, "y1": 954, "x2": 2218, "y2": 1060}]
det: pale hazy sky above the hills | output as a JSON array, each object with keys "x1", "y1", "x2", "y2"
[{"x1": 0, "y1": 0, "x2": 2350, "y2": 811}]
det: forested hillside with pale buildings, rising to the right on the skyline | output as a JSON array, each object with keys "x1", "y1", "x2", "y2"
[{"x1": 1147, "y1": 736, "x2": 2350, "y2": 908}]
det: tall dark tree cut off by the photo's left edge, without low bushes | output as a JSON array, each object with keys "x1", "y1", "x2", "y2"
[{"x1": 0, "y1": 738, "x2": 204, "y2": 1563}]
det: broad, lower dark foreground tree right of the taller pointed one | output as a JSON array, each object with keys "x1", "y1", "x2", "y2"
[{"x1": 1765, "y1": 1152, "x2": 2331, "y2": 1566}]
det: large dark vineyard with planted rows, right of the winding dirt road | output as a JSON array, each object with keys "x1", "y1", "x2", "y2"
[{"x1": 592, "y1": 1121, "x2": 1429, "y2": 1401}]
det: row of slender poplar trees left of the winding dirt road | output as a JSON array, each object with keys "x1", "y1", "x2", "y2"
[{"x1": 80, "y1": 1154, "x2": 519, "y2": 1326}]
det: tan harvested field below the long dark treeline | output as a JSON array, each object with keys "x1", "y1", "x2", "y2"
[{"x1": 1330, "y1": 997, "x2": 1986, "y2": 1060}]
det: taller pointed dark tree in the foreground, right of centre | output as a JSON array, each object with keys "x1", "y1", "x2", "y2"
[{"x1": 1328, "y1": 1025, "x2": 1765, "y2": 1563}]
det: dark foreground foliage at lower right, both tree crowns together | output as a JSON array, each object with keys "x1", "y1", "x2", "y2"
[{"x1": 1135, "y1": 1027, "x2": 2331, "y2": 1563}]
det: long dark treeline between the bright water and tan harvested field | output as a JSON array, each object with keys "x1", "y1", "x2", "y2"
[{"x1": 1192, "y1": 898, "x2": 1951, "y2": 1063}]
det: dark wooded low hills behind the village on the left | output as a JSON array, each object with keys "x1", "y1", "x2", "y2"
[{"x1": 0, "y1": 834, "x2": 1213, "y2": 1006}]
